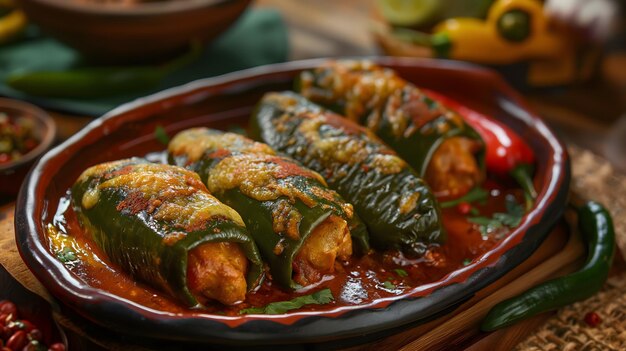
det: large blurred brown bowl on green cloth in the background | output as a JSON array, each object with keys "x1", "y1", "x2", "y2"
[{"x1": 18, "y1": 0, "x2": 250, "y2": 63}]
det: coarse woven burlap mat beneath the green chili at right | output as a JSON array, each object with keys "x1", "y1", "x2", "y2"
[{"x1": 515, "y1": 146, "x2": 626, "y2": 351}]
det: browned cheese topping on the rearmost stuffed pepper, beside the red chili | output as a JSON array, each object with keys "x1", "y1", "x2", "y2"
[{"x1": 301, "y1": 60, "x2": 463, "y2": 137}]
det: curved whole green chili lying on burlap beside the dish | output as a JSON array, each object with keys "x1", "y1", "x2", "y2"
[{"x1": 481, "y1": 201, "x2": 615, "y2": 331}]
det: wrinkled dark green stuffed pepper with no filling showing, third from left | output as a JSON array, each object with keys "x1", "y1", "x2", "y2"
[{"x1": 252, "y1": 92, "x2": 445, "y2": 255}]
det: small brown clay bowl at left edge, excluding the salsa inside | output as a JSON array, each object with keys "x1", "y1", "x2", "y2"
[{"x1": 0, "y1": 99, "x2": 56, "y2": 196}]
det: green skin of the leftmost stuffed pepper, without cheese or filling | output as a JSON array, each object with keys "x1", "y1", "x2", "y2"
[{"x1": 71, "y1": 158, "x2": 263, "y2": 308}]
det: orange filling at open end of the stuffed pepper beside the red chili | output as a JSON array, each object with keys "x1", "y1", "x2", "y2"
[{"x1": 425, "y1": 137, "x2": 482, "y2": 197}]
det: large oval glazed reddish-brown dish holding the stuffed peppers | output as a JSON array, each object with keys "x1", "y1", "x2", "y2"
[{"x1": 16, "y1": 58, "x2": 570, "y2": 345}]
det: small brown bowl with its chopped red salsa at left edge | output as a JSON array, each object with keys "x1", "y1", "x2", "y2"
[{"x1": 0, "y1": 98, "x2": 56, "y2": 195}]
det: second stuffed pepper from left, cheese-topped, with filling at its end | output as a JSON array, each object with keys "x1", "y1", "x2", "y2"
[{"x1": 168, "y1": 128, "x2": 369, "y2": 288}]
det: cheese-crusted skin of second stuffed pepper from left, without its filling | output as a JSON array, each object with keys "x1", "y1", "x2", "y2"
[{"x1": 168, "y1": 128, "x2": 369, "y2": 289}]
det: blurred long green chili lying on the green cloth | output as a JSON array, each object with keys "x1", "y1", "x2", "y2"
[{"x1": 6, "y1": 44, "x2": 201, "y2": 99}]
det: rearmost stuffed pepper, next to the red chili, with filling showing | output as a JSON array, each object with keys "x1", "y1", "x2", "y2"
[{"x1": 296, "y1": 61, "x2": 484, "y2": 197}]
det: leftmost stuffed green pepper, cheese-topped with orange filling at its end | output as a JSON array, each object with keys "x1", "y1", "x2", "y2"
[{"x1": 72, "y1": 158, "x2": 263, "y2": 307}]
